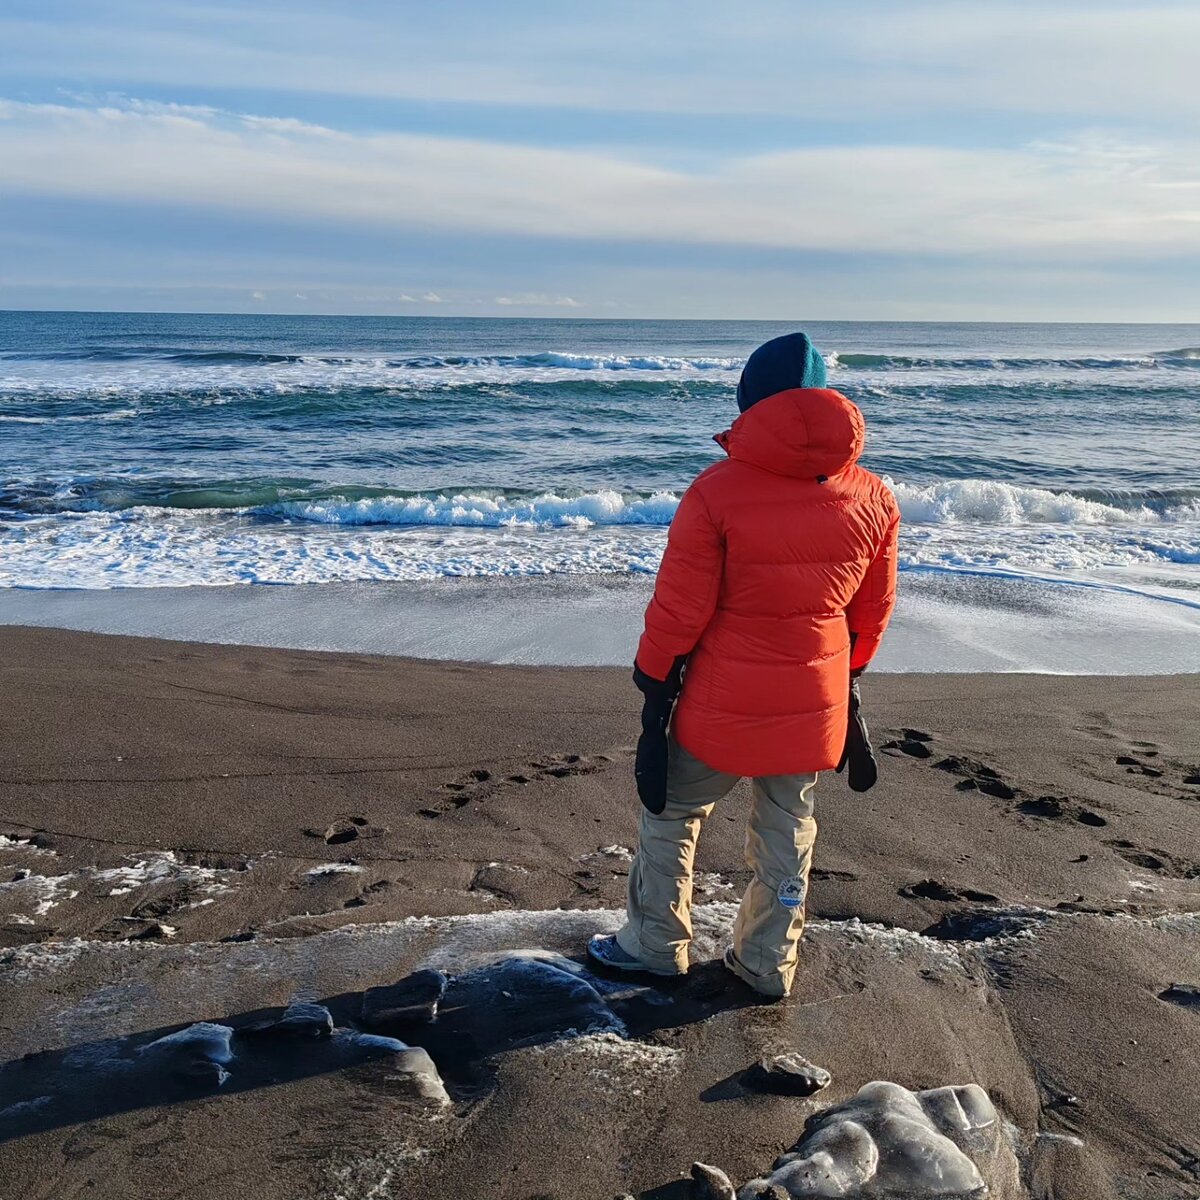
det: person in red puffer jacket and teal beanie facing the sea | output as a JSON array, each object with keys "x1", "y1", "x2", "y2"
[{"x1": 588, "y1": 334, "x2": 900, "y2": 997}]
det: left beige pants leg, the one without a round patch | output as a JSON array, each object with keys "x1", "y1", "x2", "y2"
[{"x1": 617, "y1": 738, "x2": 738, "y2": 973}]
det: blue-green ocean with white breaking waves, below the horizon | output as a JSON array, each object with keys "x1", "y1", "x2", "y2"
[{"x1": 0, "y1": 312, "x2": 1200, "y2": 667}]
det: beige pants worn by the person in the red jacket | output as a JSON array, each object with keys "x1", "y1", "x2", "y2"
[{"x1": 617, "y1": 739, "x2": 817, "y2": 996}]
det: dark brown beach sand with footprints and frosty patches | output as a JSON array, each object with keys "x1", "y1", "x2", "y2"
[{"x1": 0, "y1": 628, "x2": 1200, "y2": 1200}]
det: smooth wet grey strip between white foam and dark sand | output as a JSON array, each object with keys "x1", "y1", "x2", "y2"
[{"x1": 0, "y1": 570, "x2": 1200, "y2": 676}]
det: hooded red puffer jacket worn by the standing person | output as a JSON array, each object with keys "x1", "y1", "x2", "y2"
[{"x1": 637, "y1": 388, "x2": 900, "y2": 775}]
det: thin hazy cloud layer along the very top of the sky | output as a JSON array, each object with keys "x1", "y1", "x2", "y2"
[{"x1": 7, "y1": 0, "x2": 1200, "y2": 127}]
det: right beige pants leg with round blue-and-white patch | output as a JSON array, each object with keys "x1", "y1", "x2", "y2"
[{"x1": 732, "y1": 774, "x2": 817, "y2": 996}]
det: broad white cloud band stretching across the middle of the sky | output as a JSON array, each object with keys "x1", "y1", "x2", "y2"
[{"x1": 0, "y1": 101, "x2": 1200, "y2": 260}]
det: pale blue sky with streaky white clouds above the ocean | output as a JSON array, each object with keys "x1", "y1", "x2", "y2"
[{"x1": 0, "y1": 0, "x2": 1200, "y2": 322}]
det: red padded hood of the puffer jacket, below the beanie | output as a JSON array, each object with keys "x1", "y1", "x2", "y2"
[{"x1": 715, "y1": 388, "x2": 866, "y2": 479}]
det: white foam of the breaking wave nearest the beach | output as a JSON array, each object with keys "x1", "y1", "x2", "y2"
[{"x1": 0, "y1": 480, "x2": 1200, "y2": 588}]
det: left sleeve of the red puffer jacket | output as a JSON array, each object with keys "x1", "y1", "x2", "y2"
[{"x1": 637, "y1": 485, "x2": 725, "y2": 679}]
